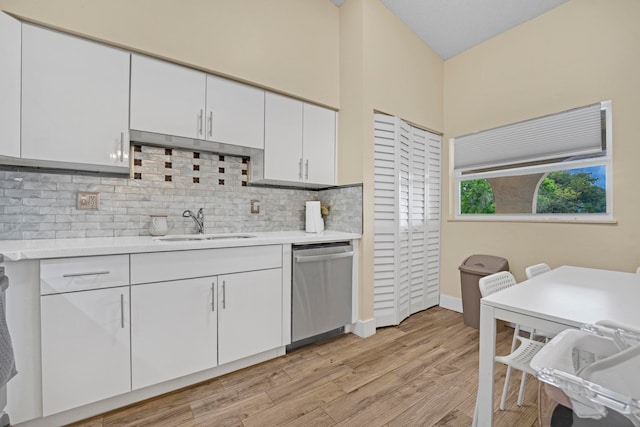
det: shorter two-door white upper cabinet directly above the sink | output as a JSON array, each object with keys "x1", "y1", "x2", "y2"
[{"x1": 131, "y1": 55, "x2": 264, "y2": 148}]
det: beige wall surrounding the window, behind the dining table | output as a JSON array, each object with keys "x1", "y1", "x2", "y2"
[{"x1": 441, "y1": 0, "x2": 640, "y2": 297}]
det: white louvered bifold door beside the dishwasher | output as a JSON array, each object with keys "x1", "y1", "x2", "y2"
[{"x1": 374, "y1": 114, "x2": 441, "y2": 327}]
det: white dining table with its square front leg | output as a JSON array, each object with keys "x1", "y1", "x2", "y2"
[{"x1": 476, "y1": 266, "x2": 640, "y2": 427}]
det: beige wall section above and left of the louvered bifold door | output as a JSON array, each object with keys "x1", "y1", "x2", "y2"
[{"x1": 338, "y1": 0, "x2": 444, "y2": 320}]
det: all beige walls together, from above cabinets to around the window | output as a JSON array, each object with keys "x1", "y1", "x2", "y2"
[{"x1": 6, "y1": 0, "x2": 624, "y2": 319}]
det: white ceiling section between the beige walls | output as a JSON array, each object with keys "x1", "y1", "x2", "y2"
[{"x1": 331, "y1": 0, "x2": 568, "y2": 60}]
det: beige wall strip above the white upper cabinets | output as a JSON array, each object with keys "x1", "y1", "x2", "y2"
[{"x1": 0, "y1": 0, "x2": 340, "y2": 108}]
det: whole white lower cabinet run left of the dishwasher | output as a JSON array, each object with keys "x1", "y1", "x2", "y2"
[{"x1": 40, "y1": 245, "x2": 290, "y2": 417}]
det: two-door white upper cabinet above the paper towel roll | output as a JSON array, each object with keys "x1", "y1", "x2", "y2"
[{"x1": 264, "y1": 92, "x2": 336, "y2": 187}]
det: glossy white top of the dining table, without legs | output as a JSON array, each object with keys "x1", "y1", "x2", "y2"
[{"x1": 482, "y1": 266, "x2": 640, "y2": 327}]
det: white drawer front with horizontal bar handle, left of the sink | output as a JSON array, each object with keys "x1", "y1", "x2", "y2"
[{"x1": 40, "y1": 255, "x2": 129, "y2": 295}]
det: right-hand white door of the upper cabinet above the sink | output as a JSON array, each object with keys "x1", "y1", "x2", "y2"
[{"x1": 206, "y1": 75, "x2": 264, "y2": 148}]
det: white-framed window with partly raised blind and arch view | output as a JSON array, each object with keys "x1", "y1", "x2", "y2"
[{"x1": 452, "y1": 101, "x2": 613, "y2": 221}]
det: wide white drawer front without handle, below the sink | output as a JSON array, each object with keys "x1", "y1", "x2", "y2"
[{"x1": 131, "y1": 245, "x2": 282, "y2": 284}]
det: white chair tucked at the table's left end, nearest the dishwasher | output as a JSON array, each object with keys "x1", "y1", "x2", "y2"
[{"x1": 479, "y1": 271, "x2": 544, "y2": 411}]
